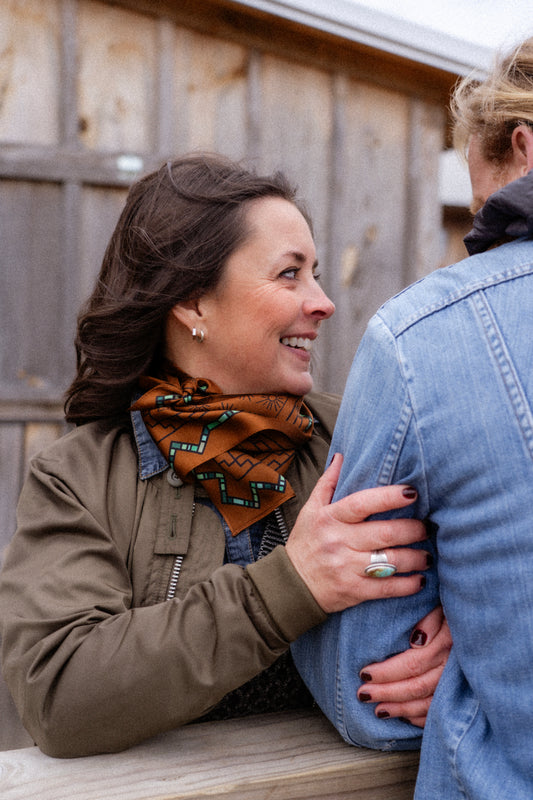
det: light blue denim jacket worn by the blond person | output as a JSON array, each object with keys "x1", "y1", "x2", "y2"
[{"x1": 293, "y1": 234, "x2": 533, "y2": 800}]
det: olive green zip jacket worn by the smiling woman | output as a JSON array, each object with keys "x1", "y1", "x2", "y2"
[{"x1": 0, "y1": 394, "x2": 338, "y2": 757}]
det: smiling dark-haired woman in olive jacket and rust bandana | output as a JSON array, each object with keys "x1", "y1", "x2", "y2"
[{"x1": 0, "y1": 155, "x2": 440, "y2": 756}]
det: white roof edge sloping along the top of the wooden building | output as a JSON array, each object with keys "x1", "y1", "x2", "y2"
[{"x1": 234, "y1": 0, "x2": 494, "y2": 75}]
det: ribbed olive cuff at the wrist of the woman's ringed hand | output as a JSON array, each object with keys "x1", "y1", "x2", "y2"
[{"x1": 246, "y1": 545, "x2": 327, "y2": 642}]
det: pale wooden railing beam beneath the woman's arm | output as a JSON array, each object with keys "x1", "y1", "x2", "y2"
[{"x1": 0, "y1": 711, "x2": 418, "y2": 800}]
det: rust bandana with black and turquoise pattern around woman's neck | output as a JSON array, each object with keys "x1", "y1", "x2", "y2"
[{"x1": 132, "y1": 374, "x2": 313, "y2": 536}]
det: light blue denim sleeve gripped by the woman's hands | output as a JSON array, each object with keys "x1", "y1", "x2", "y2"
[{"x1": 293, "y1": 315, "x2": 438, "y2": 750}]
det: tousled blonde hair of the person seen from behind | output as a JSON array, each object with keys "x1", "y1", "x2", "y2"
[{"x1": 451, "y1": 37, "x2": 533, "y2": 165}]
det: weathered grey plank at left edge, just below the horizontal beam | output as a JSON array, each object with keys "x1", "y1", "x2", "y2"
[{"x1": 0, "y1": 181, "x2": 66, "y2": 395}]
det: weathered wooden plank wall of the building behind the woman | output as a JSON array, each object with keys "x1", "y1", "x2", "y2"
[{"x1": 0, "y1": 0, "x2": 453, "y2": 748}]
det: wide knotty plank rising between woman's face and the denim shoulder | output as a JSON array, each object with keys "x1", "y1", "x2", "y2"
[{"x1": 328, "y1": 74, "x2": 409, "y2": 391}]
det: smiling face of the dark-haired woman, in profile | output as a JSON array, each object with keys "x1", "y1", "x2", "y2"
[{"x1": 190, "y1": 197, "x2": 335, "y2": 395}]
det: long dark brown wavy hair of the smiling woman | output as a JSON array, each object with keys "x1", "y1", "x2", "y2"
[{"x1": 65, "y1": 155, "x2": 305, "y2": 425}]
